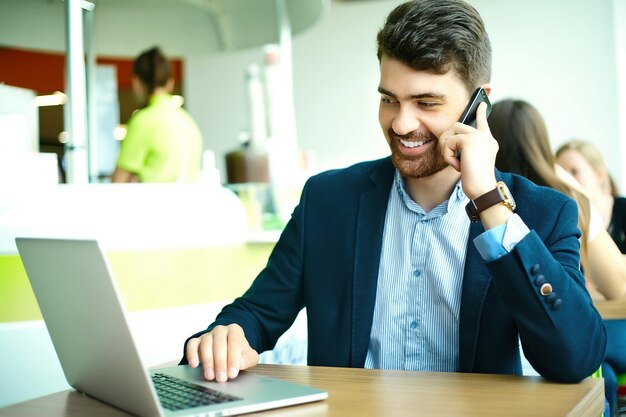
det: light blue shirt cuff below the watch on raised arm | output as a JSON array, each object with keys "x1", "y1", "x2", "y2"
[{"x1": 474, "y1": 213, "x2": 530, "y2": 262}]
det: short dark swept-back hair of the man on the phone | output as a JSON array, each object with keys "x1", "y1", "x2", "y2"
[{"x1": 376, "y1": 0, "x2": 491, "y2": 92}]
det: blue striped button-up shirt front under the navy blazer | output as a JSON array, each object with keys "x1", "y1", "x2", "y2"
[{"x1": 365, "y1": 171, "x2": 470, "y2": 372}]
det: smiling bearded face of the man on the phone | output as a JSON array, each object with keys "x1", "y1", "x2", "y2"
[{"x1": 378, "y1": 55, "x2": 470, "y2": 178}]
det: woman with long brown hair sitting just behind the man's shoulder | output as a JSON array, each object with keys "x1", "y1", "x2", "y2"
[{"x1": 489, "y1": 99, "x2": 626, "y2": 414}]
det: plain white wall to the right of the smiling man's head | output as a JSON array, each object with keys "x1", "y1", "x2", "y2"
[{"x1": 480, "y1": 0, "x2": 624, "y2": 183}]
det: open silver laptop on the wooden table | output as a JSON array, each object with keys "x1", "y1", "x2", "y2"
[{"x1": 16, "y1": 237, "x2": 328, "y2": 416}]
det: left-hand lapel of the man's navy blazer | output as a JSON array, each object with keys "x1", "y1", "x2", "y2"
[{"x1": 350, "y1": 158, "x2": 395, "y2": 367}]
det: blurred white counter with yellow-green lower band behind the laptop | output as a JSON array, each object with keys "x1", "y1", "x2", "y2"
[{"x1": 0, "y1": 184, "x2": 277, "y2": 322}]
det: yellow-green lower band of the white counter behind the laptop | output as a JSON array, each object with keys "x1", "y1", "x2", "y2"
[{"x1": 0, "y1": 244, "x2": 274, "y2": 322}]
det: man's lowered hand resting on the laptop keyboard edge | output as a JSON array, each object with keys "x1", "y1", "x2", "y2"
[{"x1": 185, "y1": 324, "x2": 259, "y2": 382}]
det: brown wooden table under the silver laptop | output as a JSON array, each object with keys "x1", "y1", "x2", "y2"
[{"x1": 0, "y1": 365, "x2": 604, "y2": 417}]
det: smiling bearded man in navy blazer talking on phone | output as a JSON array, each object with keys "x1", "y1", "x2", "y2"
[{"x1": 178, "y1": 0, "x2": 606, "y2": 382}]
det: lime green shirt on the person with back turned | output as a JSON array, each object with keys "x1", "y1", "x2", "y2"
[{"x1": 117, "y1": 94, "x2": 203, "y2": 182}]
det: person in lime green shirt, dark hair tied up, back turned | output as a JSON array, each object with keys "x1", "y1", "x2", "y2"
[{"x1": 111, "y1": 47, "x2": 203, "y2": 182}]
